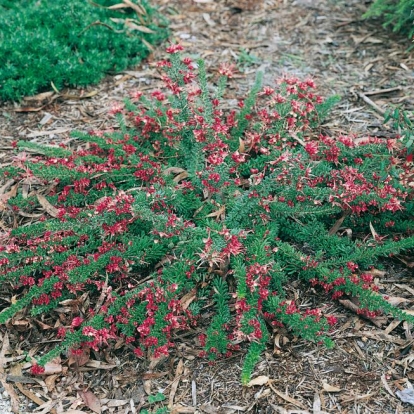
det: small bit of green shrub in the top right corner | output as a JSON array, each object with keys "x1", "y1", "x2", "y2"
[{"x1": 363, "y1": 0, "x2": 414, "y2": 38}]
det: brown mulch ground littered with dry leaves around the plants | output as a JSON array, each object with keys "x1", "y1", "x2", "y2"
[{"x1": 0, "y1": 0, "x2": 414, "y2": 414}]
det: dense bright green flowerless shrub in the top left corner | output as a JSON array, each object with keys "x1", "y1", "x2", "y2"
[{"x1": 0, "y1": 0, "x2": 167, "y2": 100}]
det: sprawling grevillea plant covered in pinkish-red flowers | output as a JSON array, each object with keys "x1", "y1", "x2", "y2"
[{"x1": 0, "y1": 45, "x2": 414, "y2": 383}]
